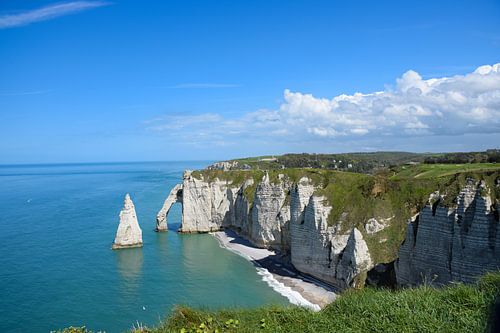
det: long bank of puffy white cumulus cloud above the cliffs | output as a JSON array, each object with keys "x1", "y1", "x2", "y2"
[{"x1": 150, "y1": 64, "x2": 500, "y2": 144}]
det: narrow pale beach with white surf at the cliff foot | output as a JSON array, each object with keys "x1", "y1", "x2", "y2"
[{"x1": 212, "y1": 230, "x2": 336, "y2": 311}]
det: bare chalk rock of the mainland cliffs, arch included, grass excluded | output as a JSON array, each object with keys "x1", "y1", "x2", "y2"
[{"x1": 158, "y1": 171, "x2": 500, "y2": 289}]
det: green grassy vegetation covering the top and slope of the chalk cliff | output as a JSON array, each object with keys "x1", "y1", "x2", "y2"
[{"x1": 193, "y1": 163, "x2": 500, "y2": 263}]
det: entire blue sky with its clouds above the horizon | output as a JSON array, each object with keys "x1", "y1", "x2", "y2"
[{"x1": 0, "y1": 0, "x2": 500, "y2": 164}]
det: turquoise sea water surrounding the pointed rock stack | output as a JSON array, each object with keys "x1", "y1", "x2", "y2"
[{"x1": 0, "y1": 162, "x2": 287, "y2": 332}]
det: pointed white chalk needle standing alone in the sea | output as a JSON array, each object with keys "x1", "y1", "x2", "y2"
[{"x1": 113, "y1": 193, "x2": 142, "y2": 249}]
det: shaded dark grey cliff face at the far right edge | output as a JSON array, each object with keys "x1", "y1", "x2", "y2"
[{"x1": 395, "y1": 180, "x2": 500, "y2": 285}]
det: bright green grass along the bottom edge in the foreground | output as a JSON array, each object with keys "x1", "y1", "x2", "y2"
[{"x1": 60, "y1": 272, "x2": 500, "y2": 333}]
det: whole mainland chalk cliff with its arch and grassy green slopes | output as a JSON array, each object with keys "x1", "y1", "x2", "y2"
[{"x1": 158, "y1": 169, "x2": 500, "y2": 289}]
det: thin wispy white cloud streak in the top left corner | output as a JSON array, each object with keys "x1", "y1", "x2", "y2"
[{"x1": 0, "y1": 1, "x2": 110, "y2": 29}]
